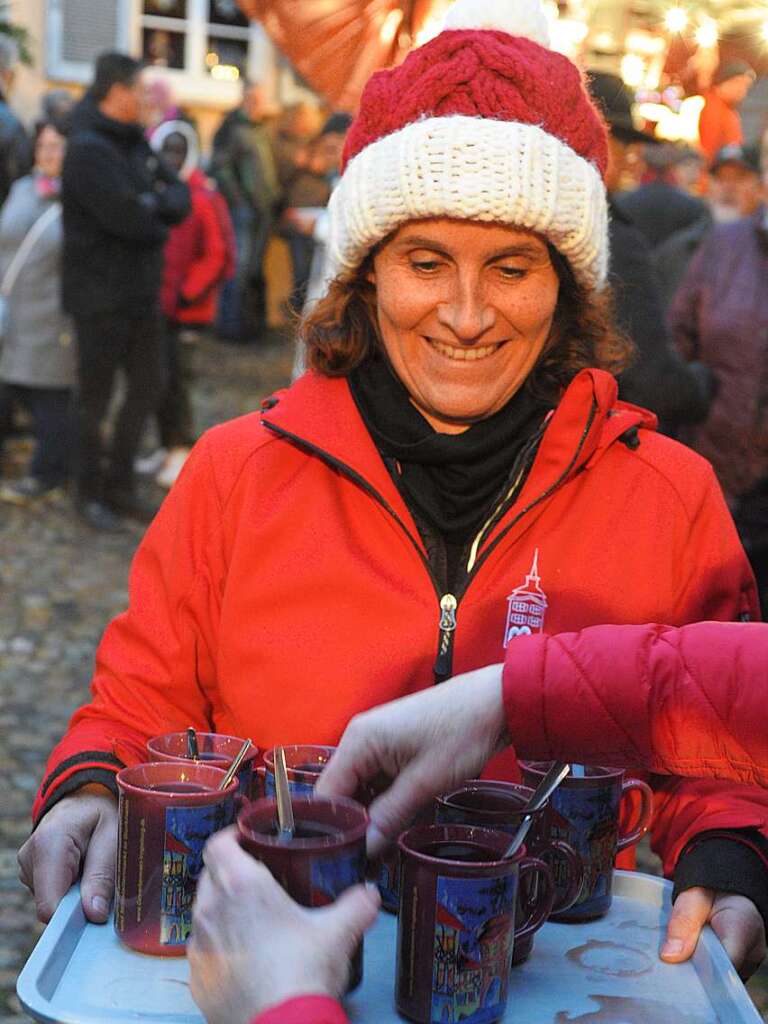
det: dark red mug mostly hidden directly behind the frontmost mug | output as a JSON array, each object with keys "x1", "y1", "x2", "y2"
[{"x1": 435, "y1": 779, "x2": 584, "y2": 967}]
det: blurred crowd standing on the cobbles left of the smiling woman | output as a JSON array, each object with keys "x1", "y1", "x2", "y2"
[{"x1": 0, "y1": 39, "x2": 349, "y2": 530}]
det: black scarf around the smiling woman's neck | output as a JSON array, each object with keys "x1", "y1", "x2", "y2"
[{"x1": 349, "y1": 356, "x2": 552, "y2": 544}]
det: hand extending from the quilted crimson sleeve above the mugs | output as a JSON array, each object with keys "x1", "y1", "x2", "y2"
[{"x1": 316, "y1": 665, "x2": 507, "y2": 856}]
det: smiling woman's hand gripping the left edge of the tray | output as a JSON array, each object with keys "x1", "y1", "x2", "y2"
[{"x1": 18, "y1": 783, "x2": 118, "y2": 925}]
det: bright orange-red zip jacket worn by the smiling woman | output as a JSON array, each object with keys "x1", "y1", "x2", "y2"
[{"x1": 34, "y1": 371, "x2": 765, "y2": 867}]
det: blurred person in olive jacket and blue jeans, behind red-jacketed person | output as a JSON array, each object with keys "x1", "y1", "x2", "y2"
[{"x1": 211, "y1": 82, "x2": 280, "y2": 343}]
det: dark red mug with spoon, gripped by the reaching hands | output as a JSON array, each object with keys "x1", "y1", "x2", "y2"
[{"x1": 238, "y1": 797, "x2": 368, "y2": 991}]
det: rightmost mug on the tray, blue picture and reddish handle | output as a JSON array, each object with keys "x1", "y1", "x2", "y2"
[{"x1": 520, "y1": 761, "x2": 653, "y2": 922}]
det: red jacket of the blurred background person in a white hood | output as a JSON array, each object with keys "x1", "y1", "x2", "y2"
[{"x1": 160, "y1": 170, "x2": 226, "y2": 324}]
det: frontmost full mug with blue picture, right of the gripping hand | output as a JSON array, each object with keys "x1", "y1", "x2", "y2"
[{"x1": 395, "y1": 825, "x2": 555, "y2": 1024}]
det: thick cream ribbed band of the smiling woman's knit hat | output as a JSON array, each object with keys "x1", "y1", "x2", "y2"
[{"x1": 329, "y1": 116, "x2": 608, "y2": 289}]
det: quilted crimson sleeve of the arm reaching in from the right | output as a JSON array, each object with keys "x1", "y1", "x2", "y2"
[{"x1": 504, "y1": 623, "x2": 768, "y2": 785}]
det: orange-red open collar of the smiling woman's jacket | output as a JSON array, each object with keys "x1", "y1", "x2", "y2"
[{"x1": 262, "y1": 370, "x2": 656, "y2": 536}]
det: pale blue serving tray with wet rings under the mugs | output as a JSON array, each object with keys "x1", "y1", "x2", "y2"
[{"x1": 16, "y1": 871, "x2": 761, "y2": 1024}]
